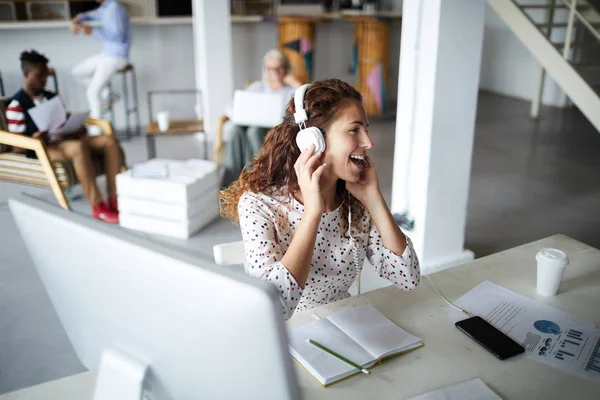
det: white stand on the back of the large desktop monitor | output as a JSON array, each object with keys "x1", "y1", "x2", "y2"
[{"x1": 94, "y1": 346, "x2": 148, "y2": 400}]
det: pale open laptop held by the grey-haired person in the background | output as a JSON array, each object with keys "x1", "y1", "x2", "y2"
[{"x1": 232, "y1": 90, "x2": 285, "y2": 128}]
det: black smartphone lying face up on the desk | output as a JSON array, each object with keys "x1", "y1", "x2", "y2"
[{"x1": 455, "y1": 317, "x2": 525, "y2": 360}]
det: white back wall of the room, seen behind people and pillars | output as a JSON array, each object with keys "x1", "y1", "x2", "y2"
[{"x1": 0, "y1": 0, "x2": 565, "y2": 134}]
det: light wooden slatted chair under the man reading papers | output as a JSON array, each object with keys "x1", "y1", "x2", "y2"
[{"x1": 0, "y1": 97, "x2": 125, "y2": 210}]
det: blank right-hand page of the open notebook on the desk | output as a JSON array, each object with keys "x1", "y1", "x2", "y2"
[{"x1": 328, "y1": 305, "x2": 422, "y2": 359}]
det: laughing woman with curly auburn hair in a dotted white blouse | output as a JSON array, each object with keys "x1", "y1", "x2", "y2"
[{"x1": 221, "y1": 79, "x2": 420, "y2": 319}]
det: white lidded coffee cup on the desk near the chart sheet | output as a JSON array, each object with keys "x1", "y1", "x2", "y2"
[{"x1": 535, "y1": 248, "x2": 569, "y2": 296}]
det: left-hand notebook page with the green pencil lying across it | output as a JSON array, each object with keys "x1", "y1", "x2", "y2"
[{"x1": 289, "y1": 319, "x2": 374, "y2": 385}]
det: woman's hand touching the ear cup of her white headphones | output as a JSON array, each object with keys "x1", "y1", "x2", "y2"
[{"x1": 294, "y1": 145, "x2": 327, "y2": 218}]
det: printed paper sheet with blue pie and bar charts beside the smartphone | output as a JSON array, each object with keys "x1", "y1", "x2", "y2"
[{"x1": 454, "y1": 281, "x2": 600, "y2": 382}]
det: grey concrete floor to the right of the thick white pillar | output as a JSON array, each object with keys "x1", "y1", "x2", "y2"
[{"x1": 465, "y1": 94, "x2": 600, "y2": 257}]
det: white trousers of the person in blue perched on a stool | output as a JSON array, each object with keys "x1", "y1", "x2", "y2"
[{"x1": 71, "y1": 54, "x2": 128, "y2": 118}]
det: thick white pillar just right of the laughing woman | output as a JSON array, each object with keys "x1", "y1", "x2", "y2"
[{"x1": 392, "y1": 0, "x2": 486, "y2": 274}]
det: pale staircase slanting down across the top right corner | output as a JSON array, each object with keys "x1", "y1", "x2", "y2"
[{"x1": 488, "y1": 0, "x2": 600, "y2": 131}]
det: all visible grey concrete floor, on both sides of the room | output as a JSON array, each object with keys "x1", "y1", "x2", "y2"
[{"x1": 0, "y1": 93, "x2": 600, "y2": 394}]
